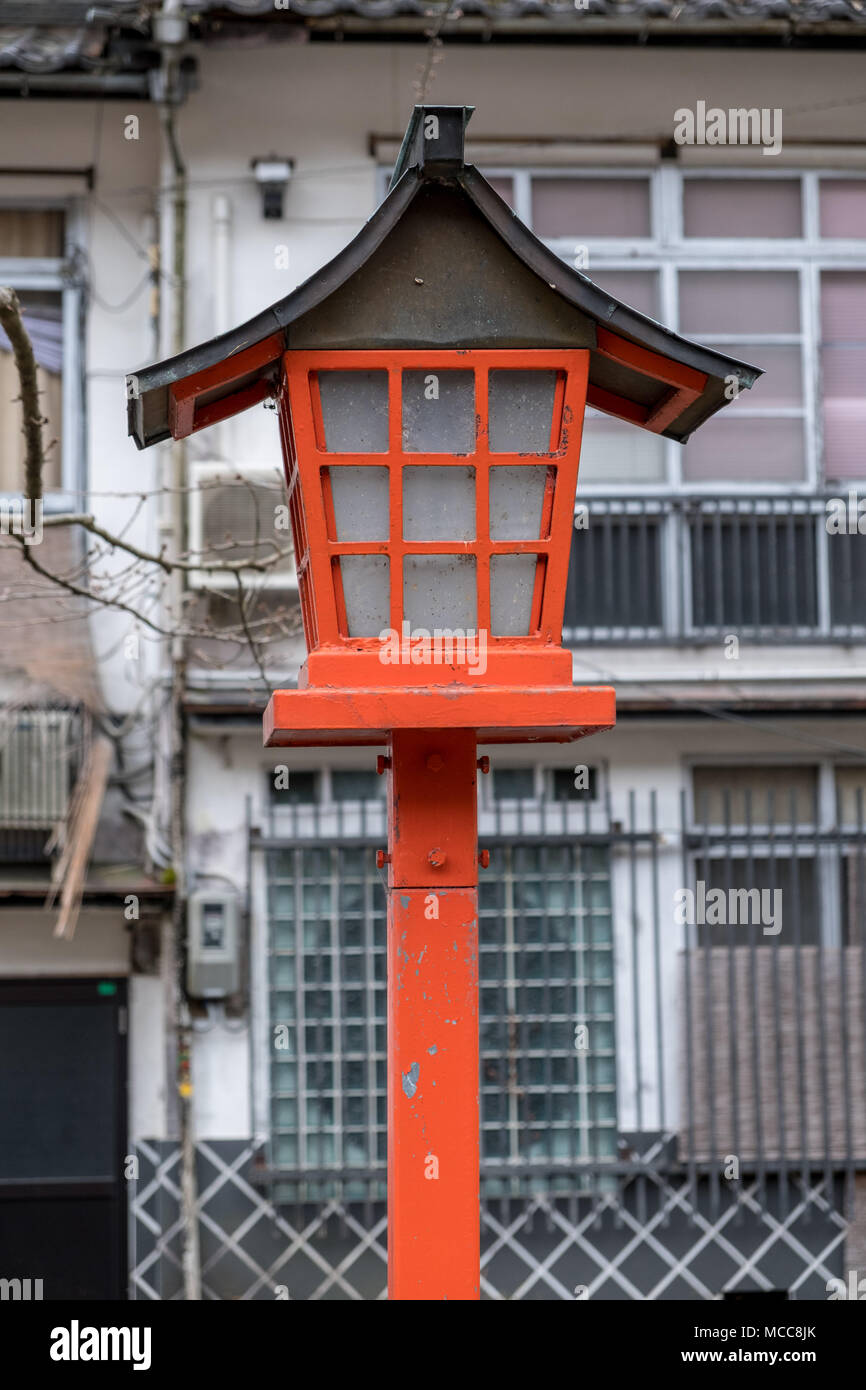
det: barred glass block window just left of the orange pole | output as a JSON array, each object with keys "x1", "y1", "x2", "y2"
[{"x1": 267, "y1": 845, "x2": 385, "y2": 1201}]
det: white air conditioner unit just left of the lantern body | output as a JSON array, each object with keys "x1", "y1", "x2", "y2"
[{"x1": 189, "y1": 461, "x2": 297, "y2": 592}]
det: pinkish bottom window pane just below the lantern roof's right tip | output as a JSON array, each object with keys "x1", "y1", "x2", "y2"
[{"x1": 683, "y1": 416, "x2": 806, "y2": 482}]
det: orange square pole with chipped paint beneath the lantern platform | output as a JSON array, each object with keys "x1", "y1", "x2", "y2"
[{"x1": 388, "y1": 728, "x2": 481, "y2": 1300}]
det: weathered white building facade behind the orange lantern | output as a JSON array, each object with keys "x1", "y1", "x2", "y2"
[{"x1": 0, "y1": 0, "x2": 866, "y2": 1300}]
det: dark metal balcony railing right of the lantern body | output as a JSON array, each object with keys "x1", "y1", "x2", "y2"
[{"x1": 564, "y1": 493, "x2": 866, "y2": 646}]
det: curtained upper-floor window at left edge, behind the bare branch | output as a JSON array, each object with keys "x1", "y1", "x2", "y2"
[{"x1": 0, "y1": 207, "x2": 81, "y2": 500}]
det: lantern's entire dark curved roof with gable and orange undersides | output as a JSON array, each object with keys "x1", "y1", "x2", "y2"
[{"x1": 126, "y1": 106, "x2": 760, "y2": 449}]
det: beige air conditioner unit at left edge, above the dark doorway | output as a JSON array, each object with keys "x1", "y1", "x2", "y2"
[{"x1": 0, "y1": 709, "x2": 78, "y2": 828}]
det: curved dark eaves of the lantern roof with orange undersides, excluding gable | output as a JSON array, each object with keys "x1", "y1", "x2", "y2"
[{"x1": 126, "y1": 128, "x2": 762, "y2": 449}]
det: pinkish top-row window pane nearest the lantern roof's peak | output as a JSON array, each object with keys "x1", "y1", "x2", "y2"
[{"x1": 532, "y1": 178, "x2": 649, "y2": 239}]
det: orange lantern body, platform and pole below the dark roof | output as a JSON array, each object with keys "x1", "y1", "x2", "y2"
[{"x1": 265, "y1": 341, "x2": 614, "y2": 1298}]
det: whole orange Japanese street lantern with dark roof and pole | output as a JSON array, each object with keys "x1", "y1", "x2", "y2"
[{"x1": 128, "y1": 107, "x2": 758, "y2": 1298}]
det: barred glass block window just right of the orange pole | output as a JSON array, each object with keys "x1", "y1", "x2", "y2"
[{"x1": 480, "y1": 844, "x2": 616, "y2": 1195}]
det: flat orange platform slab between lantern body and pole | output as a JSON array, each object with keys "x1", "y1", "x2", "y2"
[{"x1": 264, "y1": 685, "x2": 616, "y2": 748}]
